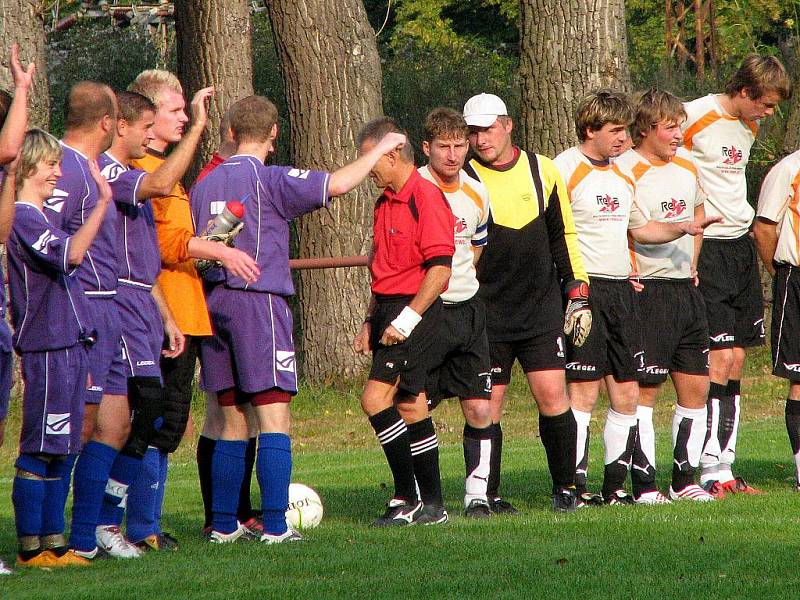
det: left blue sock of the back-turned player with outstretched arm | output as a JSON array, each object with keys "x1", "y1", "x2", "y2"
[{"x1": 211, "y1": 440, "x2": 247, "y2": 533}]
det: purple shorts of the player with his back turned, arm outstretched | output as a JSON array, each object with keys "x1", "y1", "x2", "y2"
[{"x1": 200, "y1": 285, "x2": 297, "y2": 394}]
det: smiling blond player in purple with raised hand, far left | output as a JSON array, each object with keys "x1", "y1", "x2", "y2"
[{"x1": 8, "y1": 129, "x2": 111, "y2": 567}]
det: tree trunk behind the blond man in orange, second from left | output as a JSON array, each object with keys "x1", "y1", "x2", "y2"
[{"x1": 175, "y1": 0, "x2": 253, "y2": 181}]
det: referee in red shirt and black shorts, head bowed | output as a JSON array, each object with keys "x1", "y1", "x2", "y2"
[{"x1": 354, "y1": 117, "x2": 455, "y2": 526}]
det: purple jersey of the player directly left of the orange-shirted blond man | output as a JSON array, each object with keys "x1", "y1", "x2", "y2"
[{"x1": 97, "y1": 152, "x2": 161, "y2": 287}]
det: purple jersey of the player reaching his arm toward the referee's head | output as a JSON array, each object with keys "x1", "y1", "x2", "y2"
[{"x1": 190, "y1": 155, "x2": 330, "y2": 296}]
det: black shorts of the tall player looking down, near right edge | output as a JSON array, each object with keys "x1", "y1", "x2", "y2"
[{"x1": 697, "y1": 235, "x2": 764, "y2": 350}]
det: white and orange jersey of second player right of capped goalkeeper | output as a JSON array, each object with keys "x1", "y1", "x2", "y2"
[{"x1": 615, "y1": 148, "x2": 705, "y2": 279}]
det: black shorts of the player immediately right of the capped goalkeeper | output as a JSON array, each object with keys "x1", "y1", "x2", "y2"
[{"x1": 567, "y1": 277, "x2": 644, "y2": 381}]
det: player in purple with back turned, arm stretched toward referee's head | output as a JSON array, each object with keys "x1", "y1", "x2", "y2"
[{"x1": 191, "y1": 96, "x2": 405, "y2": 544}]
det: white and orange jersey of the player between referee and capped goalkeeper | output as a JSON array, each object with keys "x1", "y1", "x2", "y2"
[{"x1": 418, "y1": 165, "x2": 489, "y2": 302}]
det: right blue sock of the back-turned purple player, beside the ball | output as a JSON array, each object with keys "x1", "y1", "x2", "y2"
[{"x1": 256, "y1": 433, "x2": 292, "y2": 534}]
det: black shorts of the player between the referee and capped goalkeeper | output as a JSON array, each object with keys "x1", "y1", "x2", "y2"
[{"x1": 425, "y1": 298, "x2": 492, "y2": 408}]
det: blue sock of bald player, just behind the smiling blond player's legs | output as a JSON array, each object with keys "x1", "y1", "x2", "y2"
[{"x1": 69, "y1": 441, "x2": 118, "y2": 552}]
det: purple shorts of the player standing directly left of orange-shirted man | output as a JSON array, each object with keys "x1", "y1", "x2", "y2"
[{"x1": 114, "y1": 284, "x2": 164, "y2": 383}]
